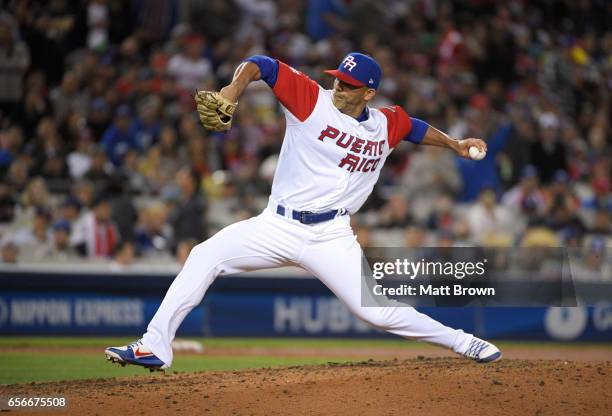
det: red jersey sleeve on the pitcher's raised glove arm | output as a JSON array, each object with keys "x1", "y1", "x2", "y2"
[{"x1": 272, "y1": 61, "x2": 319, "y2": 121}]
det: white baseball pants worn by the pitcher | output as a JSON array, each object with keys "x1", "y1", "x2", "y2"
[{"x1": 142, "y1": 204, "x2": 472, "y2": 365}]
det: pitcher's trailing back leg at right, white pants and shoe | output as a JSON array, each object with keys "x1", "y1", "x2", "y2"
[{"x1": 299, "y1": 217, "x2": 501, "y2": 362}]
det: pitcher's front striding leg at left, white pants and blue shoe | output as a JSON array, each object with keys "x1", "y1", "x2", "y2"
[{"x1": 105, "y1": 212, "x2": 301, "y2": 369}]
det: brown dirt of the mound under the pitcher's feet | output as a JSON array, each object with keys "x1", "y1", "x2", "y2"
[{"x1": 0, "y1": 357, "x2": 612, "y2": 416}]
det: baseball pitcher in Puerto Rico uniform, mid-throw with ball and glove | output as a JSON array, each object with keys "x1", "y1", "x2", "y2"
[{"x1": 105, "y1": 52, "x2": 501, "y2": 369}]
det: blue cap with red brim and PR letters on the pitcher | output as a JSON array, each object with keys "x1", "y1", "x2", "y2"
[{"x1": 325, "y1": 52, "x2": 382, "y2": 89}]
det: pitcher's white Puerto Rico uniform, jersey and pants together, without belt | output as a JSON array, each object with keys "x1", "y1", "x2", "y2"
[{"x1": 142, "y1": 62, "x2": 473, "y2": 366}]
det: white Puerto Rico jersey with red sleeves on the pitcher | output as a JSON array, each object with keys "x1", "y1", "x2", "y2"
[{"x1": 271, "y1": 62, "x2": 412, "y2": 214}]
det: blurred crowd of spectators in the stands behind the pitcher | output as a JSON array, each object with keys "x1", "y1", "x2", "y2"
[{"x1": 0, "y1": 0, "x2": 612, "y2": 280}]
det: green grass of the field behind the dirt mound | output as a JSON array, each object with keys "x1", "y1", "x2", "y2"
[{"x1": 0, "y1": 337, "x2": 612, "y2": 384}]
